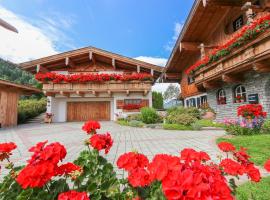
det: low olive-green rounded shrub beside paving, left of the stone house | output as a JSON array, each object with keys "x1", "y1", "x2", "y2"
[{"x1": 166, "y1": 112, "x2": 197, "y2": 126}]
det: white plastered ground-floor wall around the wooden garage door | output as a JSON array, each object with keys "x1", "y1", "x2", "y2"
[{"x1": 47, "y1": 92, "x2": 152, "y2": 122}]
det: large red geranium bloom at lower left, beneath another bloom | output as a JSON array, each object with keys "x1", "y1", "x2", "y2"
[{"x1": 16, "y1": 161, "x2": 55, "y2": 189}]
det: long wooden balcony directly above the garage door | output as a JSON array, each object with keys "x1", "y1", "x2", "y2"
[{"x1": 43, "y1": 81, "x2": 152, "y2": 96}]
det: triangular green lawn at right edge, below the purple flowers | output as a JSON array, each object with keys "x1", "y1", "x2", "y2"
[{"x1": 217, "y1": 134, "x2": 270, "y2": 166}]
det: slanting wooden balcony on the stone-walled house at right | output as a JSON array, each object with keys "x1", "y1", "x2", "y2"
[{"x1": 194, "y1": 31, "x2": 270, "y2": 89}]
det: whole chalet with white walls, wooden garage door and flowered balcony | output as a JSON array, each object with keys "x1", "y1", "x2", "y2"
[{"x1": 20, "y1": 47, "x2": 162, "y2": 122}]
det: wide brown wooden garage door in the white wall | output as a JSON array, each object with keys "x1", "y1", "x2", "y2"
[{"x1": 67, "y1": 101, "x2": 111, "y2": 122}]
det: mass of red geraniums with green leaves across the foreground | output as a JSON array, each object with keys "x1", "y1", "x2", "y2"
[{"x1": 0, "y1": 121, "x2": 270, "y2": 200}]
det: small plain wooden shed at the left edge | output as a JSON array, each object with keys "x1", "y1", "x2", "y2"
[{"x1": 0, "y1": 79, "x2": 42, "y2": 128}]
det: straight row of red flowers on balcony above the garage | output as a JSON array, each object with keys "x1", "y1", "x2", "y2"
[{"x1": 35, "y1": 72, "x2": 153, "y2": 83}]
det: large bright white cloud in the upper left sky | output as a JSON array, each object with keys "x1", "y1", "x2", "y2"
[{"x1": 0, "y1": 6, "x2": 75, "y2": 63}]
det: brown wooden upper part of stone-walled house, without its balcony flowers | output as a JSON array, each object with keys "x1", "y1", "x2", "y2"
[{"x1": 162, "y1": 0, "x2": 270, "y2": 98}]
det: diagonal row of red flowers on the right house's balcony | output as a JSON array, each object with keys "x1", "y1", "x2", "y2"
[{"x1": 185, "y1": 14, "x2": 270, "y2": 74}]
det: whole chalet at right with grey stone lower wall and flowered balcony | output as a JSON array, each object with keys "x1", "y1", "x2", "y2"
[{"x1": 162, "y1": 0, "x2": 270, "y2": 120}]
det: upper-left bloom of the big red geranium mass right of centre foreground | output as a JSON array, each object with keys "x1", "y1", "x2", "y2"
[{"x1": 117, "y1": 152, "x2": 149, "y2": 171}]
